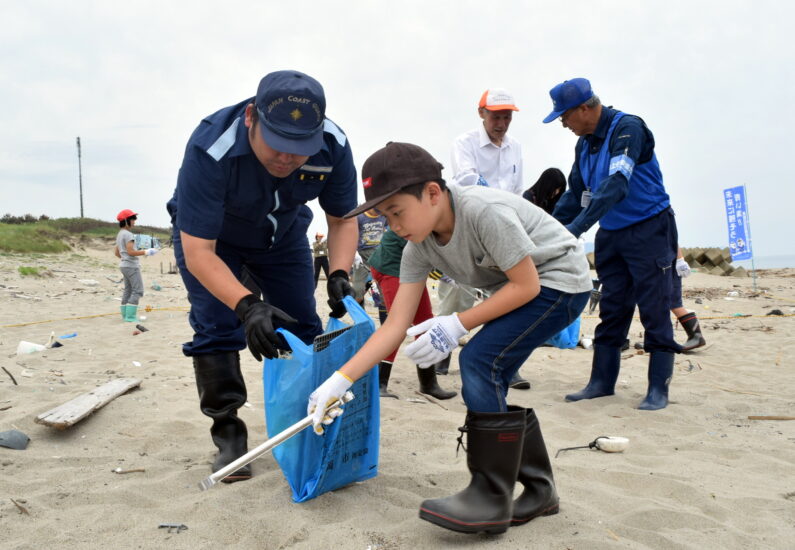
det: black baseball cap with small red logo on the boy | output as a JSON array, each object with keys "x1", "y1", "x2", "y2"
[{"x1": 343, "y1": 141, "x2": 443, "y2": 218}]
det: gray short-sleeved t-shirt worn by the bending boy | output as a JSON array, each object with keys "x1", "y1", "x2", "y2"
[{"x1": 400, "y1": 185, "x2": 593, "y2": 294}]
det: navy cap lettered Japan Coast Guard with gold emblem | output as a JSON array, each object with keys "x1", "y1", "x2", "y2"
[{"x1": 255, "y1": 71, "x2": 326, "y2": 156}]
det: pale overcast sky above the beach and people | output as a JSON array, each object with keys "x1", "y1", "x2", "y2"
[{"x1": 0, "y1": 0, "x2": 795, "y2": 256}]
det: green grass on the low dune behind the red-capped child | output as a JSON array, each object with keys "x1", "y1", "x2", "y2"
[{"x1": 0, "y1": 218, "x2": 170, "y2": 253}]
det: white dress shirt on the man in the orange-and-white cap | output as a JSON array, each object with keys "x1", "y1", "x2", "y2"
[{"x1": 452, "y1": 124, "x2": 524, "y2": 195}]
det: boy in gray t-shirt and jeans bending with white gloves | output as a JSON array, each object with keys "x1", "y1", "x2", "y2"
[{"x1": 307, "y1": 142, "x2": 592, "y2": 533}]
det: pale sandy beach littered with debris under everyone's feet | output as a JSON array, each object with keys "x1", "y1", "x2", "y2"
[{"x1": 0, "y1": 243, "x2": 795, "y2": 550}]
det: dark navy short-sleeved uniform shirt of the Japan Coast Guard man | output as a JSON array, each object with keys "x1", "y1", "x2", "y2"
[{"x1": 167, "y1": 98, "x2": 357, "y2": 249}]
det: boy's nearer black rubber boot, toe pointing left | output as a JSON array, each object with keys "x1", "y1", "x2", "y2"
[{"x1": 420, "y1": 407, "x2": 525, "y2": 534}]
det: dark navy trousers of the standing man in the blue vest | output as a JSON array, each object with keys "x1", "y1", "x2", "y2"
[{"x1": 594, "y1": 208, "x2": 681, "y2": 352}]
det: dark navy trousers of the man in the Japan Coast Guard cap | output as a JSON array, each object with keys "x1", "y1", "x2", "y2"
[{"x1": 174, "y1": 223, "x2": 323, "y2": 356}]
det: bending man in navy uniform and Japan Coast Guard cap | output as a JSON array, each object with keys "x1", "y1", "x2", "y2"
[{"x1": 167, "y1": 71, "x2": 358, "y2": 482}]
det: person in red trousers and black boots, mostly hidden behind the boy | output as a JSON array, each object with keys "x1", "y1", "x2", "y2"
[{"x1": 370, "y1": 230, "x2": 457, "y2": 399}]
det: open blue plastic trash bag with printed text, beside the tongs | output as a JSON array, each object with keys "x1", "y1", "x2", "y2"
[{"x1": 262, "y1": 296, "x2": 380, "y2": 502}]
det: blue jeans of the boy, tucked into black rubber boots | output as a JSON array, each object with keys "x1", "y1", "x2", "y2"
[{"x1": 458, "y1": 287, "x2": 591, "y2": 412}]
